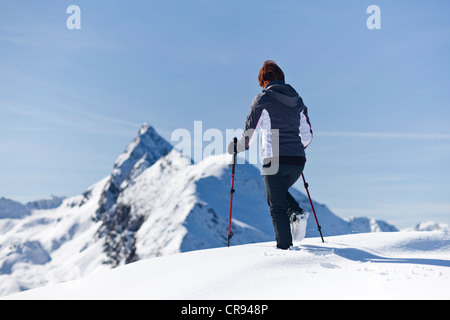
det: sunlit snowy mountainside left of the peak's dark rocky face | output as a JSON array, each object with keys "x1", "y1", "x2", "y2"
[{"x1": 0, "y1": 178, "x2": 109, "y2": 295}]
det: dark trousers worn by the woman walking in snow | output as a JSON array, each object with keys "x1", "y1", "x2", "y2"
[{"x1": 263, "y1": 164, "x2": 304, "y2": 249}]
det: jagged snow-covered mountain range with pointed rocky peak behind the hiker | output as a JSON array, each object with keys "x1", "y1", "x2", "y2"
[{"x1": 0, "y1": 124, "x2": 397, "y2": 295}]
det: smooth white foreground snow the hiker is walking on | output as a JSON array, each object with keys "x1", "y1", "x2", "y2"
[{"x1": 3, "y1": 231, "x2": 450, "y2": 300}]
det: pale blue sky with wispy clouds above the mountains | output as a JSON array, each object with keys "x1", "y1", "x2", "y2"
[{"x1": 0, "y1": 0, "x2": 450, "y2": 227}]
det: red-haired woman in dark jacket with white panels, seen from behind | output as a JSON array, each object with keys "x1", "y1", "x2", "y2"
[{"x1": 228, "y1": 60, "x2": 313, "y2": 249}]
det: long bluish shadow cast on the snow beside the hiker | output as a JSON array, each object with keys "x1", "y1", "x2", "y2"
[{"x1": 300, "y1": 245, "x2": 450, "y2": 267}]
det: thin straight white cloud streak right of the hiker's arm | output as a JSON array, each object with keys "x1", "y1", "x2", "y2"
[{"x1": 314, "y1": 131, "x2": 450, "y2": 140}]
